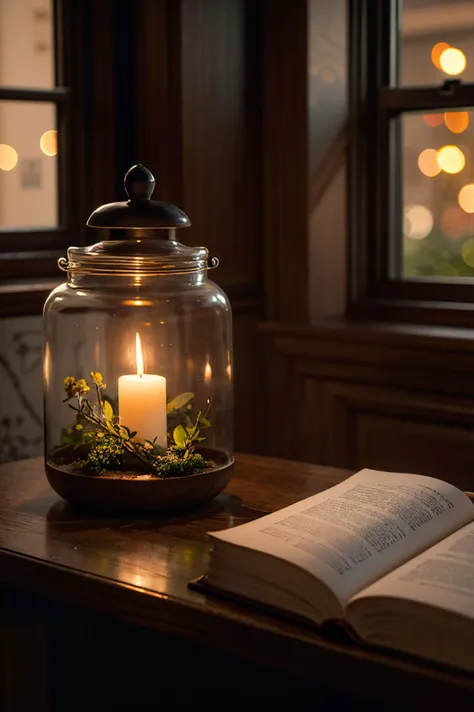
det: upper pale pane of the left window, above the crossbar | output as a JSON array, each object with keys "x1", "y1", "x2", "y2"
[{"x1": 0, "y1": 0, "x2": 55, "y2": 88}]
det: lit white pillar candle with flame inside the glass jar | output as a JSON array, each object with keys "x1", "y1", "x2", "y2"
[{"x1": 118, "y1": 334, "x2": 167, "y2": 448}]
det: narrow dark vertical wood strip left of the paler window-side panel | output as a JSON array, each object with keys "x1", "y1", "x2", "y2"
[{"x1": 262, "y1": 0, "x2": 309, "y2": 322}]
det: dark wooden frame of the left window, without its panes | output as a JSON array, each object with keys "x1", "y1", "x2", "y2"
[{"x1": 0, "y1": 0, "x2": 85, "y2": 315}]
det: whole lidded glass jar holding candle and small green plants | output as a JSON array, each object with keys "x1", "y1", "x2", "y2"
[{"x1": 44, "y1": 165, "x2": 233, "y2": 509}]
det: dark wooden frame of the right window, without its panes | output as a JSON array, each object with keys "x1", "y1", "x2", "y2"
[{"x1": 348, "y1": 0, "x2": 474, "y2": 325}]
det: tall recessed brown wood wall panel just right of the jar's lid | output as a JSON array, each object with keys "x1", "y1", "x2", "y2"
[{"x1": 181, "y1": 0, "x2": 260, "y2": 285}]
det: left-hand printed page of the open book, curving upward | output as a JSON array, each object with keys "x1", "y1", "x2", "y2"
[{"x1": 212, "y1": 470, "x2": 474, "y2": 606}]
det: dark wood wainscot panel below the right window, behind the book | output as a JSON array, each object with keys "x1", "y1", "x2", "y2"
[{"x1": 267, "y1": 322, "x2": 474, "y2": 489}]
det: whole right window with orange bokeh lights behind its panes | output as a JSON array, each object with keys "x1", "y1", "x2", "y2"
[{"x1": 350, "y1": 0, "x2": 474, "y2": 323}]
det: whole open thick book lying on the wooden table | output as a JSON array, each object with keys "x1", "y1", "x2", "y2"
[{"x1": 204, "y1": 470, "x2": 474, "y2": 671}]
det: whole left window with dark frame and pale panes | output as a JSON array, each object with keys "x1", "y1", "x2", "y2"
[{"x1": 0, "y1": 0, "x2": 84, "y2": 313}]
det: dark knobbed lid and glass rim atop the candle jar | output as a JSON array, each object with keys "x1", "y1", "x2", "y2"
[{"x1": 58, "y1": 163, "x2": 219, "y2": 275}]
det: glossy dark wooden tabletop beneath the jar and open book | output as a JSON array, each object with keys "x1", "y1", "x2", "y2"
[{"x1": 0, "y1": 455, "x2": 474, "y2": 708}]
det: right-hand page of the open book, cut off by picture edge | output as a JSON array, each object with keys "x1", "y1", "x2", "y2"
[{"x1": 355, "y1": 523, "x2": 474, "y2": 619}]
